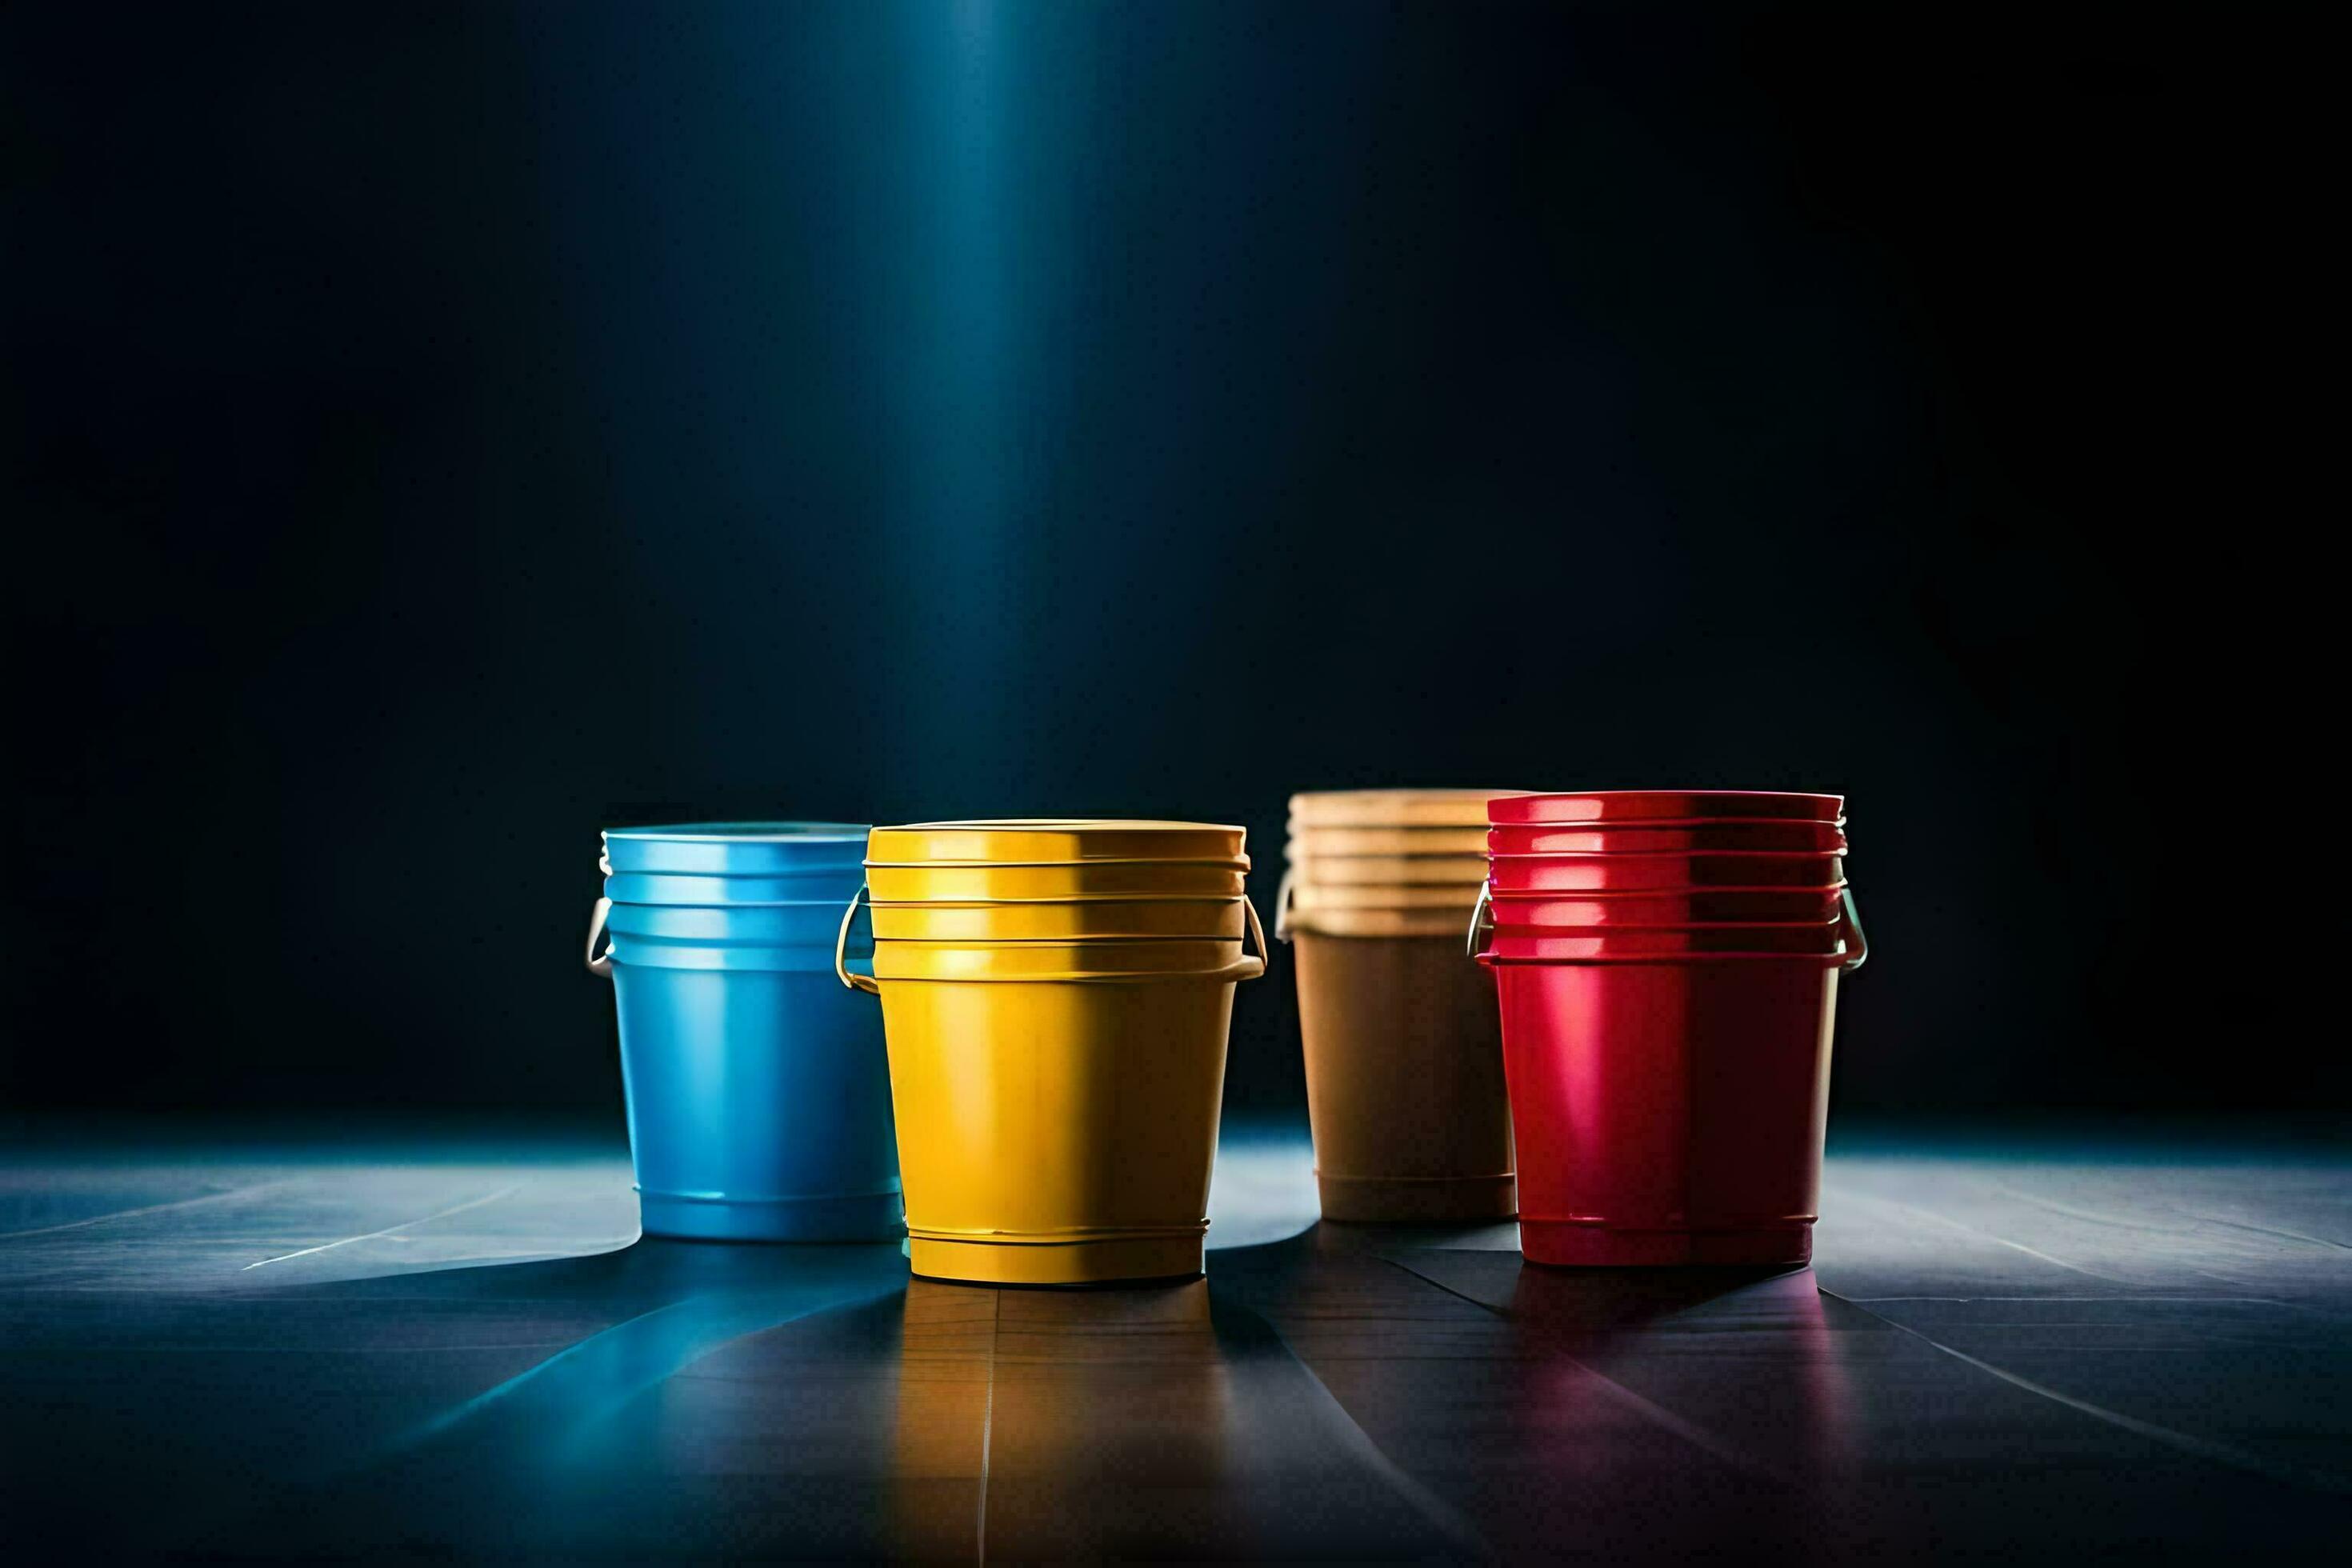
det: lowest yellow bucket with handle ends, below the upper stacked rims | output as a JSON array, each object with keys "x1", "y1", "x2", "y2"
[{"x1": 835, "y1": 900, "x2": 1266, "y2": 1286}]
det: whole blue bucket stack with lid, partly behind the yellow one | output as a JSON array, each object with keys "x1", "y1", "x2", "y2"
[{"x1": 588, "y1": 822, "x2": 906, "y2": 1242}]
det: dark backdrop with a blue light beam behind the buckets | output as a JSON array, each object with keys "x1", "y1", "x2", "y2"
[{"x1": 0, "y1": 0, "x2": 2345, "y2": 1112}]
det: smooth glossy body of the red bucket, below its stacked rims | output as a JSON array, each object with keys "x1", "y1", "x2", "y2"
[{"x1": 1494, "y1": 959, "x2": 1839, "y2": 1265}]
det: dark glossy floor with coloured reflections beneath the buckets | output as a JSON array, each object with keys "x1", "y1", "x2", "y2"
[{"x1": 0, "y1": 1128, "x2": 2352, "y2": 1563}]
